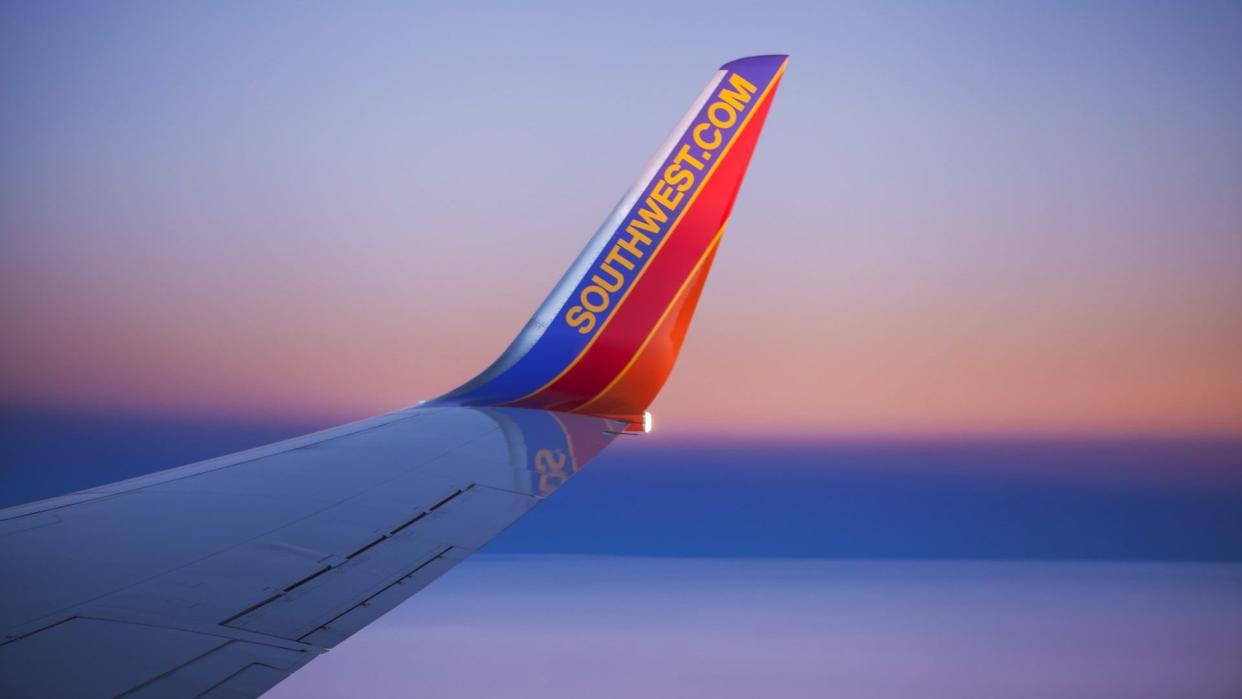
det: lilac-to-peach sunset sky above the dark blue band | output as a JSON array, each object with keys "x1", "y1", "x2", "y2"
[{"x1": 0, "y1": 2, "x2": 1242, "y2": 438}]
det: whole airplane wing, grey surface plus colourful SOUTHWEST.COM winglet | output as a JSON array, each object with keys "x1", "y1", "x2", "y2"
[{"x1": 0, "y1": 56, "x2": 786, "y2": 698}]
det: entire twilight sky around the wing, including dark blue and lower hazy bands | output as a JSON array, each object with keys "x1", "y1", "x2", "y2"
[{"x1": 0, "y1": 5, "x2": 1242, "y2": 699}]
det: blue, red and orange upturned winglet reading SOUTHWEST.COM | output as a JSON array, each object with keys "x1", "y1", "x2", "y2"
[{"x1": 435, "y1": 56, "x2": 789, "y2": 427}]
